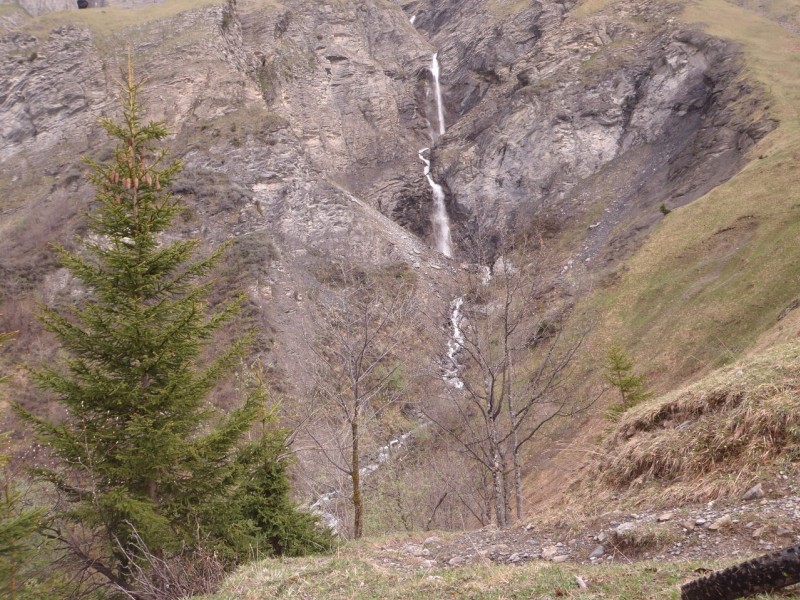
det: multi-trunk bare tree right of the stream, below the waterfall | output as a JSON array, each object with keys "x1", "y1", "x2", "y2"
[{"x1": 428, "y1": 238, "x2": 594, "y2": 526}]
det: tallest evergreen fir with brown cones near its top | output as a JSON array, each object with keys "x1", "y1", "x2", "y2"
[{"x1": 18, "y1": 66, "x2": 263, "y2": 589}]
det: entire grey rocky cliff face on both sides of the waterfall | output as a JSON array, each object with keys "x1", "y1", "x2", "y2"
[{"x1": 0, "y1": 0, "x2": 768, "y2": 256}]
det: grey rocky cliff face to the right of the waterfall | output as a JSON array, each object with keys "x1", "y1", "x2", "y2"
[{"x1": 406, "y1": 2, "x2": 771, "y2": 268}]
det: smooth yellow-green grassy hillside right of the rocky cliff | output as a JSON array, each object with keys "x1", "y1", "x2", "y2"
[{"x1": 590, "y1": 0, "x2": 800, "y2": 389}]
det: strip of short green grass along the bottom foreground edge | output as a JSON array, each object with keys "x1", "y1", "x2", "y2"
[{"x1": 205, "y1": 556, "x2": 800, "y2": 600}]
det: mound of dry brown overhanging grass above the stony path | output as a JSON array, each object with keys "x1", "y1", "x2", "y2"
[{"x1": 595, "y1": 342, "x2": 800, "y2": 500}]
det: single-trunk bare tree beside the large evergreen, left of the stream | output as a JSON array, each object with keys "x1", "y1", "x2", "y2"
[{"x1": 306, "y1": 265, "x2": 413, "y2": 538}]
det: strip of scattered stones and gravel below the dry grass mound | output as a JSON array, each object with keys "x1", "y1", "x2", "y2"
[{"x1": 367, "y1": 485, "x2": 800, "y2": 571}]
